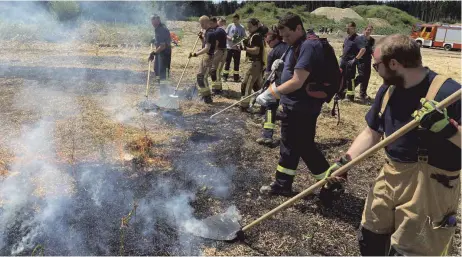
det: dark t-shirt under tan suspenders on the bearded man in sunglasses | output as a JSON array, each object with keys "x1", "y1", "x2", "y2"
[{"x1": 366, "y1": 70, "x2": 461, "y2": 171}]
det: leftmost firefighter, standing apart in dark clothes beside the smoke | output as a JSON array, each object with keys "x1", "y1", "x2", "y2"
[{"x1": 148, "y1": 15, "x2": 172, "y2": 82}]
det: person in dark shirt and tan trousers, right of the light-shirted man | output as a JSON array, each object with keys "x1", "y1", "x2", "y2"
[{"x1": 239, "y1": 18, "x2": 264, "y2": 112}]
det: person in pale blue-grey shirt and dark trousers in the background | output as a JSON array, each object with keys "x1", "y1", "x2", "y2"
[{"x1": 223, "y1": 14, "x2": 245, "y2": 82}]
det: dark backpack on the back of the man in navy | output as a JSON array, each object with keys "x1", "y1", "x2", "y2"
[{"x1": 294, "y1": 34, "x2": 342, "y2": 103}]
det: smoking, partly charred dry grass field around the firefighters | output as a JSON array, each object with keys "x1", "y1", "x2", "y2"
[{"x1": 0, "y1": 25, "x2": 461, "y2": 255}]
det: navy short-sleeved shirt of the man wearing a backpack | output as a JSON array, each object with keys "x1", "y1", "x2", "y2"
[{"x1": 281, "y1": 35, "x2": 324, "y2": 111}]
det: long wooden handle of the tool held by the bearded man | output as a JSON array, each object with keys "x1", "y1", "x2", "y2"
[{"x1": 242, "y1": 89, "x2": 461, "y2": 232}]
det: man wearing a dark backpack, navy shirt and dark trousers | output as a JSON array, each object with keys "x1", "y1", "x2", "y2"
[{"x1": 257, "y1": 13, "x2": 329, "y2": 196}]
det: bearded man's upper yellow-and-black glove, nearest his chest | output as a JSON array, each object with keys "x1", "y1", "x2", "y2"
[{"x1": 412, "y1": 98, "x2": 458, "y2": 138}]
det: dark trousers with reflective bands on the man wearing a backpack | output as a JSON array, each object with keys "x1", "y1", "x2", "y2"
[{"x1": 276, "y1": 105, "x2": 329, "y2": 188}]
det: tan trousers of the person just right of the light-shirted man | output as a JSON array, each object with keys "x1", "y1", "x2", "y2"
[{"x1": 241, "y1": 61, "x2": 263, "y2": 108}]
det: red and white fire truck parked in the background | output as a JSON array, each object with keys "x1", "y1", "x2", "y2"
[{"x1": 411, "y1": 24, "x2": 462, "y2": 51}]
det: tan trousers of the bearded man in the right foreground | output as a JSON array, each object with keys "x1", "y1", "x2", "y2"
[{"x1": 359, "y1": 157, "x2": 460, "y2": 256}]
